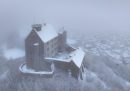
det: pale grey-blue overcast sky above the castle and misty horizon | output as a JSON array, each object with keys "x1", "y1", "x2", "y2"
[{"x1": 0, "y1": 0, "x2": 130, "y2": 47}]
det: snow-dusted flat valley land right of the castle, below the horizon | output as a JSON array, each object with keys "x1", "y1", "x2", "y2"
[{"x1": 82, "y1": 35, "x2": 130, "y2": 64}]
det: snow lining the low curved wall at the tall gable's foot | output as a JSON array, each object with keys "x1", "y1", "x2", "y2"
[{"x1": 19, "y1": 64, "x2": 54, "y2": 75}]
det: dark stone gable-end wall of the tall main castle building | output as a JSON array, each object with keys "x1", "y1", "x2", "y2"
[{"x1": 25, "y1": 30, "x2": 44, "y2": 68}]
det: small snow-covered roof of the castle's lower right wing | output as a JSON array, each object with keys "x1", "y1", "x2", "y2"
[{"x1": 70, "y1": 47, "x2": 85, "y2": 68}]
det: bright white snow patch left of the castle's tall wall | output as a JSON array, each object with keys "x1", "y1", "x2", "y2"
[{"x1": 3, "y1": 48, "x2": 25, "y2": 60}]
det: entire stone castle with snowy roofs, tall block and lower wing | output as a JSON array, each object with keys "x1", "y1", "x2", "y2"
[{"x1": 25, "y1": 24, "x2": 85, "y2": 79}]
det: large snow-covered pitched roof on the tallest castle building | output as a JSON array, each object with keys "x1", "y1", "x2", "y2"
[{"x1": 36, "y1": 24, "x2": 58, "y2": 43}]
